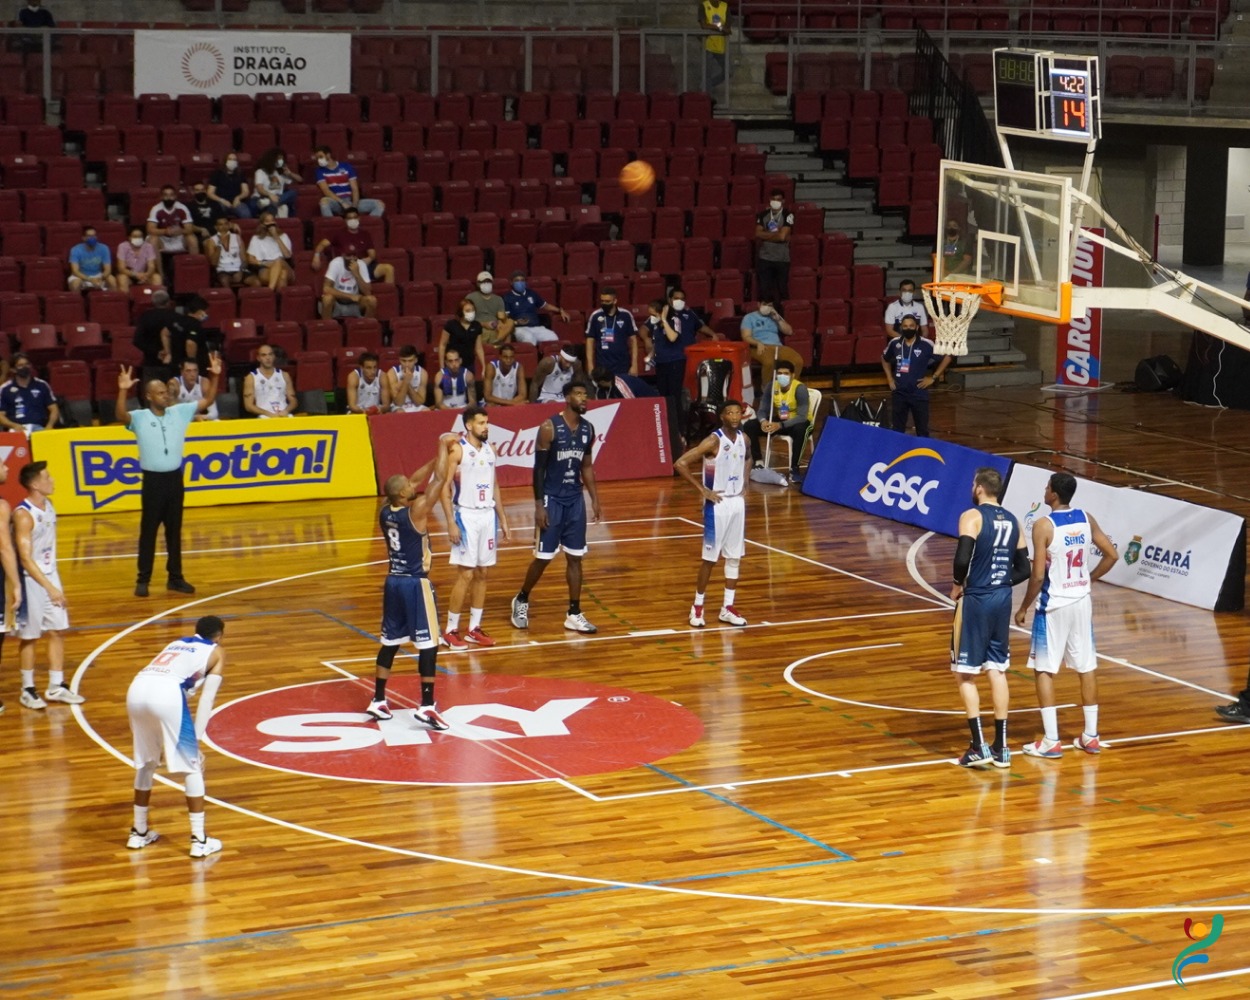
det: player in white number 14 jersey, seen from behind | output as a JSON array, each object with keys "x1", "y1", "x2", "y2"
[{"x1": 1015, "y1": 473, "x2": 1119, "y2": 760}]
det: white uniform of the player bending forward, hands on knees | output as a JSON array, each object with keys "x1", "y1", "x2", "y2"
[{"x1": 126, "y1": 635, "x2": 218, "y2": 774}]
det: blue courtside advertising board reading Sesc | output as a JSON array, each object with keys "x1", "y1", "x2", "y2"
[{"x1": 803, "y1": 420, "x2": 1011, "y2": 538}]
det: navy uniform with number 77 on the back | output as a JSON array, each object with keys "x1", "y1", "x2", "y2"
[{"x1": 950, "y1": 504, "x2": 1020, "y2": 674}]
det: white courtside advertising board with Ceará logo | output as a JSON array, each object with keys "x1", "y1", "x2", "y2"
[{"x1": 1003, "y1": 464, "x2": 1245, "y2": 610}]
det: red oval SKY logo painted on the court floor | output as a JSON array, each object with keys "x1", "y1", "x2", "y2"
[{"x1": 208, "y1": 674, "x2": 703, "y2": 785}]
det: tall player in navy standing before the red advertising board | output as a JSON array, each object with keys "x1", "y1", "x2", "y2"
[{"x1": 513, "y1": 380, "x2": 604, "y2": 635}]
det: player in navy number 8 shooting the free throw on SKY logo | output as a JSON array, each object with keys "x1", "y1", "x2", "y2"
[{"x1": 365, "y1": 450, "x2": 449, "y2": 733}]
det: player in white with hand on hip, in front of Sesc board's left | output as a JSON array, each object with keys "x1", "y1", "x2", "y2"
[{"x1": 676, "y1": 399, "x2": 749, "y2": 629}]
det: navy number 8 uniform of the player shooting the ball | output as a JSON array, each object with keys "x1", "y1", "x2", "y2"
[{"x1": 379, "y1": 504, "x2": 439, "y2": 649}]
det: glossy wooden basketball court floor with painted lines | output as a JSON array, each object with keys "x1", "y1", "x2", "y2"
[{"x1": 0, "y1": 390, "x2": 1250, "y2": 1000}]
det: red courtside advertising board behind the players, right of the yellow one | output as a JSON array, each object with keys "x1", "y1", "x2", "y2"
[{"x1": 369, "y1": 398, "x2": 674, "y2": 494}]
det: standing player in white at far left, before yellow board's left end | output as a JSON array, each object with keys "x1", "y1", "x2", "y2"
[{"x1": 13, "y1": 461, "x2": 86, "y2": 710}]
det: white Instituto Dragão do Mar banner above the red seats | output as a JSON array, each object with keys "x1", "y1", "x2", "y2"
[{"x1": 135, "y1": 31, "x2": 351, "y2": 98}]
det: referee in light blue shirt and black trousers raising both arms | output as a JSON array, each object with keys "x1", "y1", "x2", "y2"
[{"x1": 116, "y1": 354, "x2": 221, "y2": 598}]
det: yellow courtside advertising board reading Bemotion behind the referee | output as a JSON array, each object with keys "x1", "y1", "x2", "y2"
[{"x1": 30, "y1": 415, "x2": 378, "y2": 514}]
